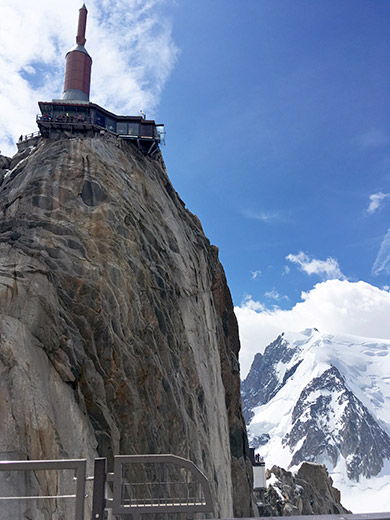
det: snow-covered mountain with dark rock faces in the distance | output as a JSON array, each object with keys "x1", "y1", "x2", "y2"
[{"x1": 242, "y1": 329, "x2": 390, "y2": 512}]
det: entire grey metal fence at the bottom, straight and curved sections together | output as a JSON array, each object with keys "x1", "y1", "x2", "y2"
[{"x1": 0, "y1": 455, "x2": 213, "y2": 520}]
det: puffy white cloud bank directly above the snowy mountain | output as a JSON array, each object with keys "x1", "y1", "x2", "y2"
[{"x1": 235, "y1": 280, "x2": 390, "y2": 378}]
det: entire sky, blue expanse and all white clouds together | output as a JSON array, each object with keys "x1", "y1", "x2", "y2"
[{"x1": 0, "y1": 0, "x2": 390, "y2": 370}]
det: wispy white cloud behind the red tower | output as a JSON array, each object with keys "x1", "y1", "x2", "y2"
[{"x1": 0, "y1": 0, "x2": 178, "y2": 155}]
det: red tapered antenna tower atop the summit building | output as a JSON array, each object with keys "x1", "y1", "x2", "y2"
[{"x1": 62, "y1": 4, "x2": 92, "y2": 101}]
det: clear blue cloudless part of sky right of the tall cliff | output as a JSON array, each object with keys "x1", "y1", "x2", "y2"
[{"x1": 159, "y1": 0, "x2": 390, "y2": 300}]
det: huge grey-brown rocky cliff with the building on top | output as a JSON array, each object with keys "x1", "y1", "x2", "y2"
[{"x1": 0, "y1": 134, "x2": 253, "y2": 520}]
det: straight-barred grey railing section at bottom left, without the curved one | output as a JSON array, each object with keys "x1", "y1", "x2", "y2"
[{"x1": 0, "y1": 459, "x2": 87, "y2": 520}]
